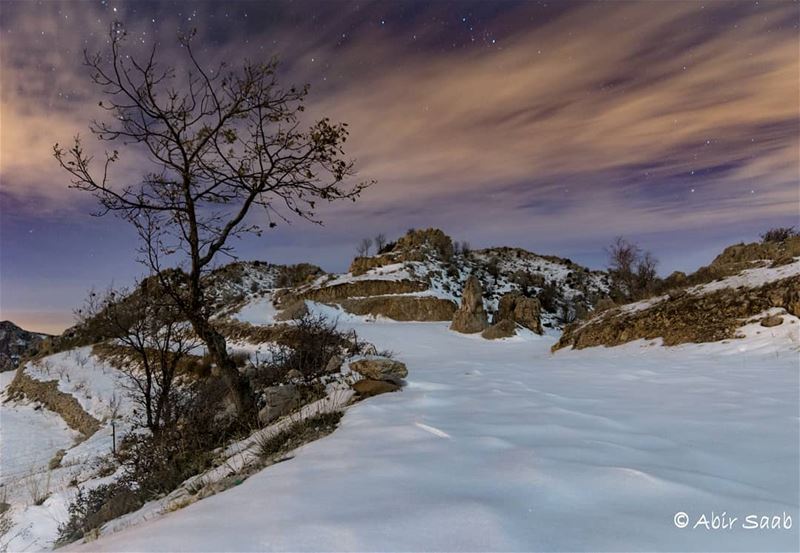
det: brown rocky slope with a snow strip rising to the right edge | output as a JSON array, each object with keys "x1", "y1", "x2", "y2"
[{"x1": 554, "y1": 238, "x2": 800, "y2": 349}]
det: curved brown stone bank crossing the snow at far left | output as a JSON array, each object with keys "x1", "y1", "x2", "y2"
[{"x1": 8, "y1": 367, "x2": 100, "y2": 437}]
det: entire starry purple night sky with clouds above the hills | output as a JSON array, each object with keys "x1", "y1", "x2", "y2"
[{"x1": 0, "y1": 0, "x2": 800, "y2": 331}]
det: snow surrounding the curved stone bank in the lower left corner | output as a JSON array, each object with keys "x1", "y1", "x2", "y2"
[{"x1": 0, "y1": 347, "x2": 133, "y2": 551}]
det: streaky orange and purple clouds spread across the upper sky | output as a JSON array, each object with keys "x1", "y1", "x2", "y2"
[{"x1": 0, "y1": 2, "x2": 800, "y2": 244}]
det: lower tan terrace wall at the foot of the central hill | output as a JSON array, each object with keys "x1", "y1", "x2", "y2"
[{"x1": 340, "y1": 296, "x2": 456, "y2": 321}]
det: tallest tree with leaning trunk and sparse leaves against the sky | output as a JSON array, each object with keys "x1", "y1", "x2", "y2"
[{"x1": 54, "y1": 24, "x2": 370, "y2": 416}]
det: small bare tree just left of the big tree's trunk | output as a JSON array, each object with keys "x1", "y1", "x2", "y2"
[{"x1": 76, "y1": 279, "x2": 199, "y2": 433}]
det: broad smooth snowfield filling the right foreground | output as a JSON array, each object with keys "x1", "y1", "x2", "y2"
[{"x1": 73, "y1": 316, "x2": 800, "y2": 551}]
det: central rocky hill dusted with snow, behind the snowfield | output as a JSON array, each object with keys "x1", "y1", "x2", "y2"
[{"x1": 276, "y1": 229, "x2": 608, "y2": 329}]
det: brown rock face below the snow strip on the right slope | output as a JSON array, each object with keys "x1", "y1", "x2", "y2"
[{"x1": 553, "y1": 277, "x2": 800, "y2": 350}]
